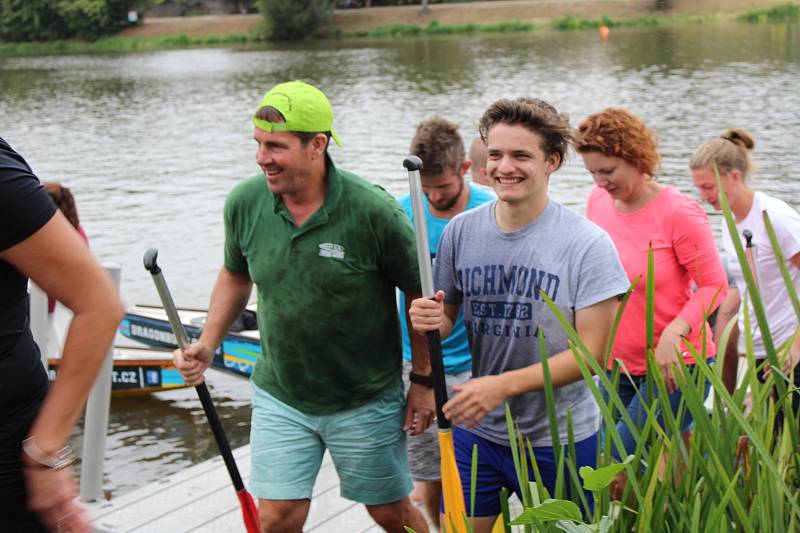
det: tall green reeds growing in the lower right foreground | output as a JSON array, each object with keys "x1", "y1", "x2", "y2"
[{"x1": 410, "y1": 162, "x2": 800, "y2": 533}]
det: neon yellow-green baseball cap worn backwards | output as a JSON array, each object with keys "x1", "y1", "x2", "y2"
[{"x1": 253, "y1": 81, "x2": 342, "y2": 146}]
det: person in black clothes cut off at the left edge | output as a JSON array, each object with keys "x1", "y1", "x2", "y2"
[{"x1": 0, "y1": 138, "x2": 124, "y2": 533}]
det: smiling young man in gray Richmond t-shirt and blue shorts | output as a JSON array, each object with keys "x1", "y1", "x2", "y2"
[{"x1": 410, "y1": 98, "x2": 629, "y2": 533}]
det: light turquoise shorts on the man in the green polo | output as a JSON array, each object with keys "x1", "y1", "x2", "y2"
[{"x1": 250, "y1": 385, "x2": 413, "y2": 505}]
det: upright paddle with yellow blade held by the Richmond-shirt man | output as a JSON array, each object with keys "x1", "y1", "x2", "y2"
[{"x1": 403, "y1": 155, "x2": 466, "y2": 533}]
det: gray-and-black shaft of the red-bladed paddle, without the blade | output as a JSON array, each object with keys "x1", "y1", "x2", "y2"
[{"x1": 144, "y1": 248, "x2": 244, "y2": 492}]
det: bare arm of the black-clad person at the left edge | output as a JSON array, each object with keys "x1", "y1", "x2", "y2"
[{"x1": 0, "y1": 213, "x2": 124, "y2": 454}]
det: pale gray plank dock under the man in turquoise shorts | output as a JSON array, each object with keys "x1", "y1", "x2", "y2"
[{"x1": 88, "y1": 446, "x2": 383, "y2": 533}]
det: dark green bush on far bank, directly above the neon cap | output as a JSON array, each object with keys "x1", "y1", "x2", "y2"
[{"x1": 259, "y1": 0, "x2": 333, "y2": 41}]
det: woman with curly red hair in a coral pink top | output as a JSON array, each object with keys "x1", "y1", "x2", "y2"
[{"x1": 575, "y1": 108, "x2": 728, "y2": 460}]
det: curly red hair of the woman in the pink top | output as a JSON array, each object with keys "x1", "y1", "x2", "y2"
[{"x1": 575, "y1": 107, "x2": 659, "y2": 176}]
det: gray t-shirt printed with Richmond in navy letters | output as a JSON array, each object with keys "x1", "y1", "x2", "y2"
[{"x1": 434, "y1": 200, "x2": 629, "y2": 447}]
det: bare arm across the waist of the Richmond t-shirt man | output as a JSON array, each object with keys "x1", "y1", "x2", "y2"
[{"x1": 444, "y1": 298, "x2": 618, "y2": 428}]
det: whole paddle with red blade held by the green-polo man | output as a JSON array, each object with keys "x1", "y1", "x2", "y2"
[{"x1": 144, "y1": 248, "x2": 261, "y2": 533}]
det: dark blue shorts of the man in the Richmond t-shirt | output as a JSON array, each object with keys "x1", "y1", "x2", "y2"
[{"x1": 453, "y1": 428, "x2": 597, "y2": 516}]
